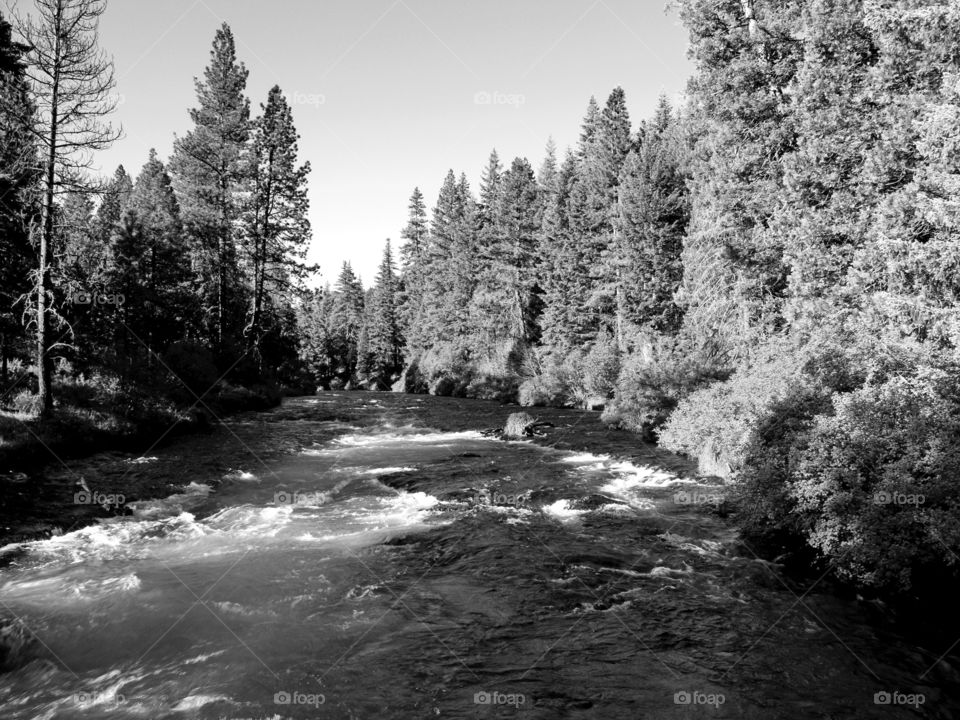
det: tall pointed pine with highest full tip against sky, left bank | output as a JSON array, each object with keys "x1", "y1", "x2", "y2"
[{"x1": 171, "y1": 23, "x2": 251, "y2": 355}]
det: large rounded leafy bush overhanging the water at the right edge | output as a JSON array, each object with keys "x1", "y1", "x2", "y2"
[{"x1": 751, "y1": 364, "x2": 960, "y2": 592}]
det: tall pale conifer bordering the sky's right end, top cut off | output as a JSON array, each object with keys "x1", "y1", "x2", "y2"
[{"x1": 681, "y1": 0, "x2": 808, "y2": 358}]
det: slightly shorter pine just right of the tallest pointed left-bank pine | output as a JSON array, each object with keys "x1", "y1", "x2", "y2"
[{"x1": 245, "y1": 86, "x2": 316, "y2": 367}]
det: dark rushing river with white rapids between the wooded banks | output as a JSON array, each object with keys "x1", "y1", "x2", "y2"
[{"x1": 0, "y1": 393, "x2": 960, "y2": 720}]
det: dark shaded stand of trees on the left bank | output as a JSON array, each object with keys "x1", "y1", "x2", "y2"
[{"x1": 0, "y1": 0, "x2": 316, "y2": 414}]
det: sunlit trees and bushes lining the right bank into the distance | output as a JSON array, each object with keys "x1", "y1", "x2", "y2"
[{"x1": 312, "y1": 0, "x2": 960, "y2": 599}]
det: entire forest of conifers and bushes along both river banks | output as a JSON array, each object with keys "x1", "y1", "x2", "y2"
[{"x1": 0, "y1": 0, "x2": 960, "y2": 608}]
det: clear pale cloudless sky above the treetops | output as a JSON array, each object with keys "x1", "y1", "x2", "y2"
[{"x1": 86, "y1": 0, "x2": 691, "y2": 283}]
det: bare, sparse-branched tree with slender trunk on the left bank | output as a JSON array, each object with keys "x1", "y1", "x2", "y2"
[{"x1": 18, "y1": 0, "x2": 120, "y2": 414}]
